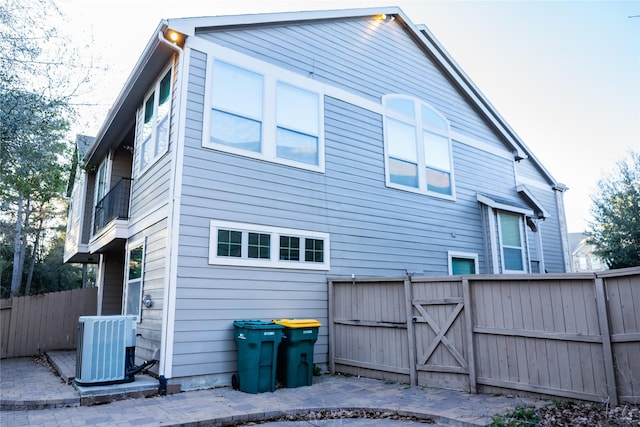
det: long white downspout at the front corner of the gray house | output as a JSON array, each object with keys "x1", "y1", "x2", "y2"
[{"x1": 158, "y1": 27, "x2": 184, "y2": 395}]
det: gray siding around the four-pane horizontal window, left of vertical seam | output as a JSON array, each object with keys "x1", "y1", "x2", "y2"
[{"x1": 173, "y1": 52, "x2": 328, "y2": 382}]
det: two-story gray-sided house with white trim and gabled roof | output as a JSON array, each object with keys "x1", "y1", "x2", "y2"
[{"x1": 65, "y1": 8, "x2": 571, "y2": 390}]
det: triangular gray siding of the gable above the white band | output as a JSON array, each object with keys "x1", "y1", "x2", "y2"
[{"x1": 200, "y1": 19, "x2": 506, "y2": 148}]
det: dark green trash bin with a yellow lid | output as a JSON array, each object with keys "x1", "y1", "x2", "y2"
[{"x1": 274, "y1": 319, "x2": 320, "y2": 388}]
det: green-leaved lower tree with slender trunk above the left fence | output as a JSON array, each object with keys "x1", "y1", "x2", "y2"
[{"x1": 0, "y1": 89, "x2": 68, "y2": 296}]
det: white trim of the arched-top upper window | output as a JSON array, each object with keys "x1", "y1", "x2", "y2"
[{"x1": 382, "y1": 94, "x2": 456, "y2": 200}]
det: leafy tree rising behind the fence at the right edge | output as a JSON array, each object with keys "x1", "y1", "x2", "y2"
[{"x1": 588, "y1": 151, "x2": 640, "y2": 268}]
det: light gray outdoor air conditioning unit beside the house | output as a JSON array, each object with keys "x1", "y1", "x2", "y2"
[{"x1": 75, "y1": 316, "x2": 136, "y2": 386}]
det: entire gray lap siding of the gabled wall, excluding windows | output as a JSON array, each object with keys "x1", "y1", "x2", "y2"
[{"x1": 172, "y1": 20, "x2": 568, "y2": 383}]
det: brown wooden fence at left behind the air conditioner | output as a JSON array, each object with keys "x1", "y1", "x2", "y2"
[{"x1": 0, "y1": 288, "x2": 98, "y2": 359}]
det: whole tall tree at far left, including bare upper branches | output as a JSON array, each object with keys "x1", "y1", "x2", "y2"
[{"x1": 0, "y1": 0, "x2": 93, "y2": 295}]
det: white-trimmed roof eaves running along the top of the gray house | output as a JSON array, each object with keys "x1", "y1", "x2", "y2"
[{"x1": 85, "y1": 7, "x2": 566, "y2": 190}]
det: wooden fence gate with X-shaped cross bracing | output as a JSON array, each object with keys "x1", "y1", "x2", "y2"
[{"x1": 411, "y1": 280, "x2": 472, "y2": 391}]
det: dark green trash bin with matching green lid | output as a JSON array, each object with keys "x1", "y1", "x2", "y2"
[{"x1": 231, "y1": 320, "x2": 283, "y2": 393}]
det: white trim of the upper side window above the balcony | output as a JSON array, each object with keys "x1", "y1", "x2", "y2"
[{"x1": 133, "y1": 64, "x2": 175, "y2": 178}]
